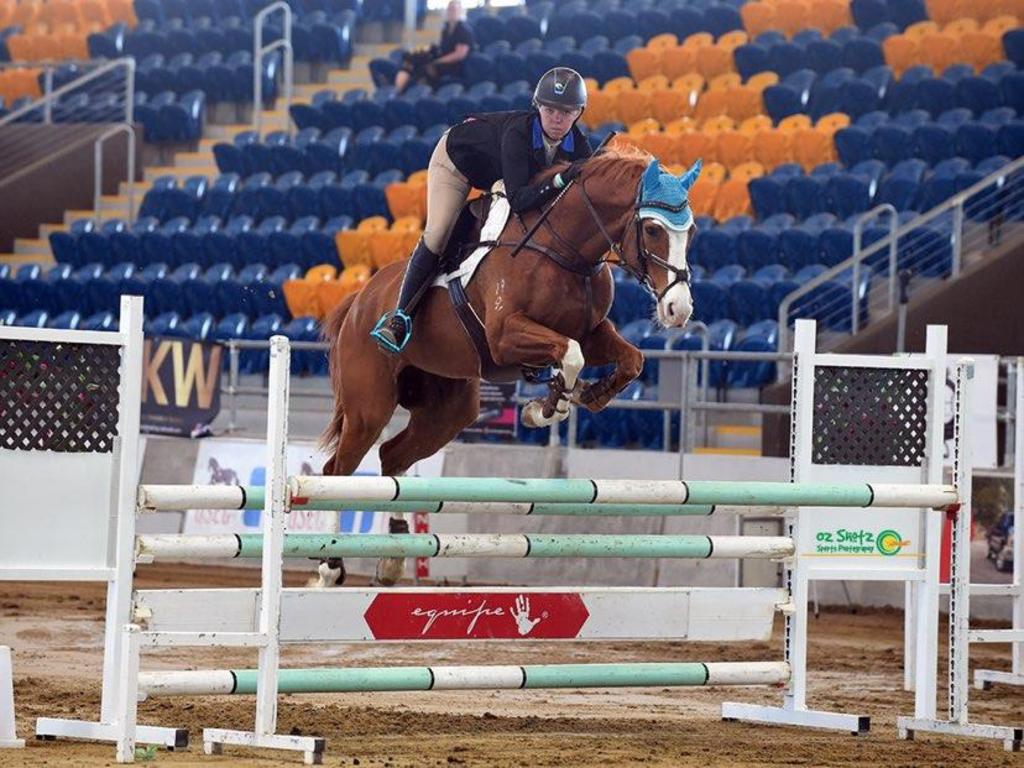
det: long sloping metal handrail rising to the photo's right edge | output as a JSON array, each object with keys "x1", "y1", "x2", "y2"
[{"x1": 778, "y1": 157, "x2": 1024, "y2": 360}]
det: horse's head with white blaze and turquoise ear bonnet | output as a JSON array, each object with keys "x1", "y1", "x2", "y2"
[{"x1": 622, "y1": 160, "x2": 700, "y2": 328}]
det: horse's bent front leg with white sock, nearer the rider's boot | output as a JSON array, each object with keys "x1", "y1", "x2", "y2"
[{"x1": 487, "y1": 312, "x2": 584, "y2": 434}]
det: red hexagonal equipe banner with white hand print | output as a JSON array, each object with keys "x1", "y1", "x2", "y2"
[{"x1": 364, "y1": 592, "x2": 590, "y2": 640}]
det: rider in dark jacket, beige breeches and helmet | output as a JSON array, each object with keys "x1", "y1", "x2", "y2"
[{"x1": 372, "y1": 67, "x2": 591, "y2": 353}]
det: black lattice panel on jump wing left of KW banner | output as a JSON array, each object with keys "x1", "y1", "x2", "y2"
[{"x1": 0, "y1": 340, "x2": 121, "y2": 454}]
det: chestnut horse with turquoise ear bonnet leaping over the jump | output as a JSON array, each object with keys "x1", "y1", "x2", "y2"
[{"x1": 319, "y1": 145, "x2": 700, "y2": 586}]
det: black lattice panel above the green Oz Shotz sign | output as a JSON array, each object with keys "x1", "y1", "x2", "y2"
[{"x1": 811, "y1": 366, "x2": 929, "y2": 467}]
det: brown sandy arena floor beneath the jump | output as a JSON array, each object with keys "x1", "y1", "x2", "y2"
[{"x1": 0, "y1": 564, "x2": 1024, "y2": 768}]
